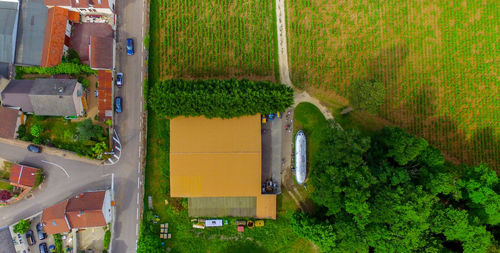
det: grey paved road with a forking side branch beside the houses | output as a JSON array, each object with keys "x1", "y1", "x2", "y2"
[{"x1": 0, "y1": 0, "x2": 145, "y2": 253}]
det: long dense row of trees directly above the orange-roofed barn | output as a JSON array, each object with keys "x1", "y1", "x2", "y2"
[{"x1": 148, "y1": 79, "x2": 293, "y2": 118}]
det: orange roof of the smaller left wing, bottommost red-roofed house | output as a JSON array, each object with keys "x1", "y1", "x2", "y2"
[{"x1": 42, "y1": 200, "x2": 70, "y2": 234}]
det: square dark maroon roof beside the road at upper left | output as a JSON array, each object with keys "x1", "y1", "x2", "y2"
[{"x1": 89, "y1": 36, "x2": 113, "y2": 69}]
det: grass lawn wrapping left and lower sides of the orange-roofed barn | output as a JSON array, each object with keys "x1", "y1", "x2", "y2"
[{"x1": 144, "y1": 113, "x2": 314, "y2": 252}]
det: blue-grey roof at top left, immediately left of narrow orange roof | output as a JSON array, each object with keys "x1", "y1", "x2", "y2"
[{"x1": 15, "y1": 0, "x2": 48, "y2": 66}]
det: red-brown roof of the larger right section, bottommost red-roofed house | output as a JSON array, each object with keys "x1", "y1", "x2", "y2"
[{"x1": 66, "y1": 191, "x2": 106, "y2": 228}]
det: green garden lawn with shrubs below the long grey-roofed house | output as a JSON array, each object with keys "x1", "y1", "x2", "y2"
[{"x1": 20, "y1": 115, "x2": 108, "y2": 158}]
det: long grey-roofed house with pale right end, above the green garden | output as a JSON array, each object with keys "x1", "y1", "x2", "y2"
[{"x1": 1, "y1": 79, "x2": 85, "y2": 116}]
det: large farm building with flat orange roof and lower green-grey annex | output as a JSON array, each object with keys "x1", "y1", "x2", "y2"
[{"x1": 170, "y1": 115, "x2": 276, "y2": 219}]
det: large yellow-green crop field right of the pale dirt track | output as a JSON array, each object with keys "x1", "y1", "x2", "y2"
[{"x1": 287, "y1": 0, "x2": 500, "y2": 171}]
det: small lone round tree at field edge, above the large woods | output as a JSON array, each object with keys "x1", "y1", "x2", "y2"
[{"x1": 349, "y1": 80, "x2": 385, "y2": 114}]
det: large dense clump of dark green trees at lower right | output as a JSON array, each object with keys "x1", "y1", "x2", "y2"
[{"x1": 291, "y1": 127, "x2": 500, "y2": 252}]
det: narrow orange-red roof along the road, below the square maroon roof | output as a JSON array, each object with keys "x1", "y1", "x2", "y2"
[{"x1": 97, "y1": 70, "x2": 113, "y2": 120}]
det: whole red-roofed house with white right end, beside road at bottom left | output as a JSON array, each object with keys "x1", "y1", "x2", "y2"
[{"x1": 42, "y1": 190, "x2": 112, "y2": 234}]
